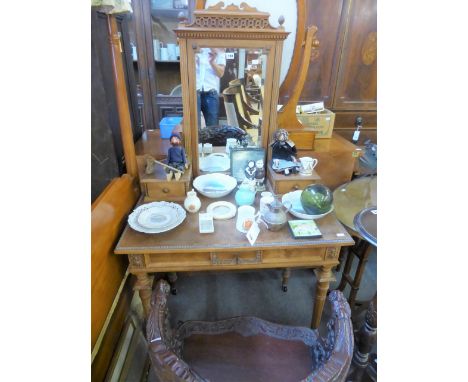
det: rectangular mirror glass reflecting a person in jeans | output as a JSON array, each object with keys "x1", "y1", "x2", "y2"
[{"x1": 195, "y1": 47, "x2": 267, "y2": 172}]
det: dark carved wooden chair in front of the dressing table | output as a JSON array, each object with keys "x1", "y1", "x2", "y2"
[{"x1": 146, "y1": 280, "x2": 353, "y2": 382}]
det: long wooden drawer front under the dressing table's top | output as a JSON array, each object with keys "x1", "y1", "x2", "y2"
[{"x1": 145, "y1": 248, "x2": 333, "y2": 271}]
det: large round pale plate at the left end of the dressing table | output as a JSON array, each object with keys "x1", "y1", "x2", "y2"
[{"x1": 128, "y1": 202, "x2": 187, "y2": 233}]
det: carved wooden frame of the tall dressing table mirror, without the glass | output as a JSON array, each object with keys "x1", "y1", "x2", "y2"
[{"x1": 175, "y1": 2, "x2": 289, "y2": 176}]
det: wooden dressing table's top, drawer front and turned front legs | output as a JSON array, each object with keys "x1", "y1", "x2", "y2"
[{"x1": 114, "y1": 192, "x2": 354, "y2": 329}]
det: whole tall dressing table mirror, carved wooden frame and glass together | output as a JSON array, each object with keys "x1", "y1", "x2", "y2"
[{"x1": 175, "y1": 2, "x2": 288, "y2": 176}]
